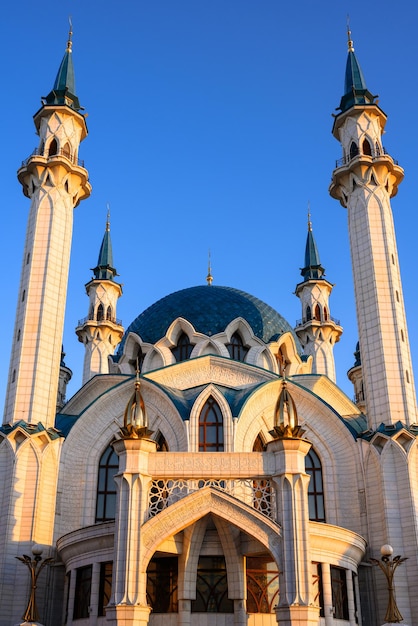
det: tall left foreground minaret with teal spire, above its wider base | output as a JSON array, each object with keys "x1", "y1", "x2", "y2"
[{"x1": 3, "y1": 31, "x2": 91, "y2": 427}]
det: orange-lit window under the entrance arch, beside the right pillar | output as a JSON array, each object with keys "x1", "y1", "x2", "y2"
[{"x1": 247, "y1": 556, "x2": 279, "y2": 613}]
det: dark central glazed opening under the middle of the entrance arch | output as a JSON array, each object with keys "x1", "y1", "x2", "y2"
[{"x1": 192, "y1": 556, "x2": 234, "y2": 613}]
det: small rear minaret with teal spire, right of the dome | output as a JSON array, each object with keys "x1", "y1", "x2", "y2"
[{"x1": 295, "y1": 213, "x2": 343, "y2": 382}]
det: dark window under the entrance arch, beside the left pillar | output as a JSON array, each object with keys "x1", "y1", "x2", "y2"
[{"x1": 147, "y1": 556, "x2": 178, "y2": 613}]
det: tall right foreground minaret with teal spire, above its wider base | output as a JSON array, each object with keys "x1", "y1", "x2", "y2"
[{"x1": 330, "y1": 32, "x2": 417, "y2": 429}]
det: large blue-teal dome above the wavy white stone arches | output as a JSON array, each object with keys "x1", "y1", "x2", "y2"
[{"x1": 118, "y1": 285, "x2": 302, "y2": 355}]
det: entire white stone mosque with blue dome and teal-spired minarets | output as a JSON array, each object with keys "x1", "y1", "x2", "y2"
[{"x1": 0, "y1": 22, "x2": 418, "y2": 626}]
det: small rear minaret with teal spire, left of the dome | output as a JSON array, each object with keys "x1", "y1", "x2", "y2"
[{"x1": 75, "y1": 212, "x2": 123, "y2": 385}]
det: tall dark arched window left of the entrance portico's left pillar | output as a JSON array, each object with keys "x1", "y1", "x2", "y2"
[{"x1": 96, "y1": 446, "x2": 119, "y2": 522}]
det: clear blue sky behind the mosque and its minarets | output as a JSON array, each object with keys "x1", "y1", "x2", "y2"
[{"x1": 0, "y1": 0, "x2": 418, "y2": 404}]
